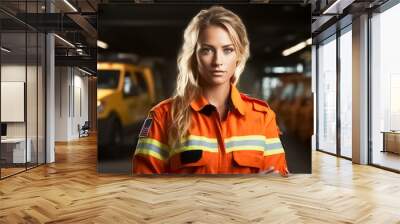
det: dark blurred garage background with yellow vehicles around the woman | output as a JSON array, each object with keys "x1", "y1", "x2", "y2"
[{"x1": 97, "y1": 4, "x2": 313, "y2": 173}]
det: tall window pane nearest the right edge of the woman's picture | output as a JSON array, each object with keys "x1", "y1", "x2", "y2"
[{"x1": 318, "y1": 36, "x2": 336, "y2": 154}]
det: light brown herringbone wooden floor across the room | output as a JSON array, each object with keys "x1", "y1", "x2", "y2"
[{"x1": 0, "y1": 137, "x2": 400, "y2": 224}]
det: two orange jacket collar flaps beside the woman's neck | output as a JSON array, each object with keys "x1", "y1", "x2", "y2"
[{"x1": 190, "y1": 84, "x2": 245, "y2": 115}]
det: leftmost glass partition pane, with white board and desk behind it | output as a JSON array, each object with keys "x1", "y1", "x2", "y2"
[{"x1": 1, "y1": 32, "x2": 27, "y2": 178}]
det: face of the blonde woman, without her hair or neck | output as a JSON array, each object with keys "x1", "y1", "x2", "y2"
[{"x1": 196, "y1": 25, "x2": 238, "y2": 86}]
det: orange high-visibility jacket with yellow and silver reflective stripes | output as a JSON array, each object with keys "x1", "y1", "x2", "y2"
[{"x1": 133, "y1": 85, "x2": 287, "y2": 175}]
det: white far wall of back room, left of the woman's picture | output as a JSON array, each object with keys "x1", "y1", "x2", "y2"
[{"x1": 55, "y1": 67, "x2": 88, "y2": 141}]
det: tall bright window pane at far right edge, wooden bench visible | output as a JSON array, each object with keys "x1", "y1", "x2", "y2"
[{"x1": 371, "y1": 4, "x2": 400, "y2": 170}]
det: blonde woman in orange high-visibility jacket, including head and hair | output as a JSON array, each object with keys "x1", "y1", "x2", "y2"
[{"x1": 133, "y1": 6, "x2": 288, "y2": 176}]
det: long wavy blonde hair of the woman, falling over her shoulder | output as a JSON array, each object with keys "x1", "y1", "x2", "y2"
[{"x1": 168, "y1": 6, "x2": 250, "y2": 147}]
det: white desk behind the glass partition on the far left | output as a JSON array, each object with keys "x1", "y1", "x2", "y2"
[{"x1": 1, "y1": 138, "x2": 32, "y2": 163}]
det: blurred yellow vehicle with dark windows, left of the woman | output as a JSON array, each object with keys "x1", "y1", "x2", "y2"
[{"x1": 97, "y1": 62, "x2": 155, "y2": 146}]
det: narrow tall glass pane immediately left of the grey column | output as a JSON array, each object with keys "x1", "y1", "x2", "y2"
[{"x1": 340, "y1": 30, "x2": 353, "y2": 158}]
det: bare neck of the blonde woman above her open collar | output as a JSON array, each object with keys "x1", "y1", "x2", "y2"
[{"x1": 203, "y1": 83, "x2": 230, "y2": 119}]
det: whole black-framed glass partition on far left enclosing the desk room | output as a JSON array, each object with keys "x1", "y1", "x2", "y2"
[{"x1": 0, "y1": 1, "x2": 46, "y2": 179}]
